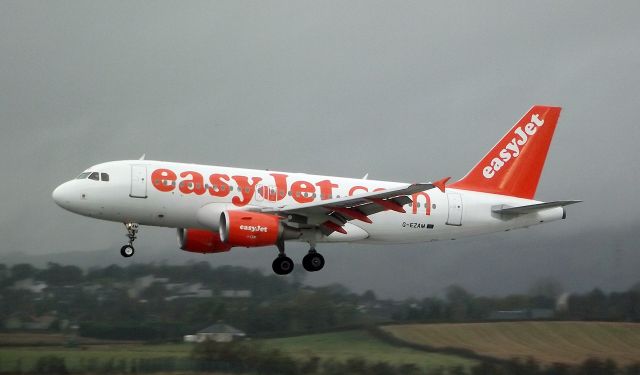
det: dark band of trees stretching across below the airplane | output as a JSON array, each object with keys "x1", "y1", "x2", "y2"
[{"x1": 0, "y1": 262, "x2": 640, "y2": 341}]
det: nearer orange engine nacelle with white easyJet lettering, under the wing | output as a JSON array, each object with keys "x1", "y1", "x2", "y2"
[{"x1": 220, "y1": 211, "x2": 302, "y2": 247}]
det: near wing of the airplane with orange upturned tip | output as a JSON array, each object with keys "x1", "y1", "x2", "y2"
[{"x1": 261, "y1": 178, "x2": 448, "y2": 235}]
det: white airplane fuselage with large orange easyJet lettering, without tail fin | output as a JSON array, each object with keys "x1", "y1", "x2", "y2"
[{"x1": 53, "y1": 160, "x2": 564, "y2": 243}]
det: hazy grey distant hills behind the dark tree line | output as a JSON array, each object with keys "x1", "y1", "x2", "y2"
[{"x1": 0, "y1": 224, "x2": 640, "y2": 299}]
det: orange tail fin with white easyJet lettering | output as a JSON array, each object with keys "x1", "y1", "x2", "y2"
[{"x1": 448, "y1": 105, "x2": 561, "y2": 199}]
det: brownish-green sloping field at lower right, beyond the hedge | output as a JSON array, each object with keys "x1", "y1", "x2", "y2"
[{"x1": 382, "y1": 322, "x2": 640, "y2": 364}]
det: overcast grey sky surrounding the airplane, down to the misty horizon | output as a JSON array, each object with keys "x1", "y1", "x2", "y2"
[{"x1": 0, "y1": 1, "x2": 640, "y2": 296}]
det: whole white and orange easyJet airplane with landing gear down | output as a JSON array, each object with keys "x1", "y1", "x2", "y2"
[{"x1": 52, "y1": 105, "x2": 580, "y2": 275}]
